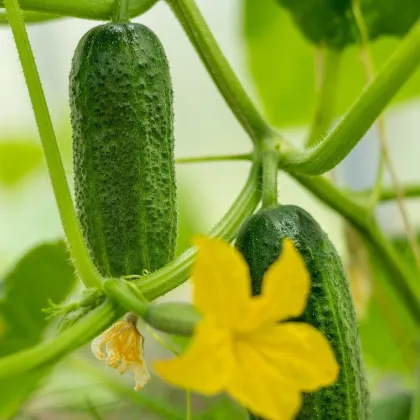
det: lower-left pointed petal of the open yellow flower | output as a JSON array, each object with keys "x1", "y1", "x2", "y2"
[{"x1": 154, "y1": 321, "x2": 232, "y2": 395}]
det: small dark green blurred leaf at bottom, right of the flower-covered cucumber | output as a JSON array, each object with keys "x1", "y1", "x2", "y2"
[{"x1": 372, "y1": 392, "x2": 411, "y2": 420}]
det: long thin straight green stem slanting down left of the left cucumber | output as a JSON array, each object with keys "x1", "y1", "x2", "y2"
[{"x1": 4, "y1": 0, "x2": 102, "y2": 287}]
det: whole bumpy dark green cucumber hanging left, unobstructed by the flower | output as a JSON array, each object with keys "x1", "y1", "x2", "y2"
[{"x1": 70, "y1": 23, "x2": 177, "y2": 276}]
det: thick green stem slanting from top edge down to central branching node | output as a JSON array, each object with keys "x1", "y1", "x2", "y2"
[{"x1": 166, "y1": 0, "x2": 271, "y2": 144}]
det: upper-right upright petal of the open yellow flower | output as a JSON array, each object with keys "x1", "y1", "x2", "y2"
[{"x1": 250, "y1": 239, "x2": 310, "y2": 329}]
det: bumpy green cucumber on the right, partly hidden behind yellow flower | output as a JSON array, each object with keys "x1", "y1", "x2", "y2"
[{"x1": 236, "y1": 205, "x2": 370, "y2": 420}]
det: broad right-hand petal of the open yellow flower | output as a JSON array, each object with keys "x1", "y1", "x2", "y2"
[{"x1": 246, "y1": 322, "x2": 339, "y2": 392}]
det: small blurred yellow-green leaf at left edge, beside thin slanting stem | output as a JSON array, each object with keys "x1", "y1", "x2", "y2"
[{"x1": 0, "y1": 141, "x2": 43, "y2": 186}]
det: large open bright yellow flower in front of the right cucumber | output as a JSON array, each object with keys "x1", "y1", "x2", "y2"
[{"x1": 154, "y1": 238, "x2": 339, "y2": 420}]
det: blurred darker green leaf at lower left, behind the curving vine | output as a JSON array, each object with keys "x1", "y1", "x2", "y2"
[{"x1": 0, "y1": 241, "x2": 75, "y2": 419}]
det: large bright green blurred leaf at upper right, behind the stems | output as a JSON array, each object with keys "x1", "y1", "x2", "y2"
[{"x1": 243, "y1": 0, "x2": 420, "y2": 126}]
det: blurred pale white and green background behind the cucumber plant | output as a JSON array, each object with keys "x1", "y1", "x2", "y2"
[{"x1": 0, "y1": 0, "x2": 420, "y2": 420}]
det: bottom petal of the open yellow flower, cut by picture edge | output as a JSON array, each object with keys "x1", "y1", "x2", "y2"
[{"x1": 226, "y1": 342, "x2": 302, "y2": 420}]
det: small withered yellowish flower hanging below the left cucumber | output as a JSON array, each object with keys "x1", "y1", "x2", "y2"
[{"x1": 92, "y1": 314, "x2": 150, "y2": 391}]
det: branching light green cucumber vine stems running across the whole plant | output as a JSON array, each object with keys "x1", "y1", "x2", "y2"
[{"x1": 0, "y1": 0, "x2": 420, "y2": 388}]
